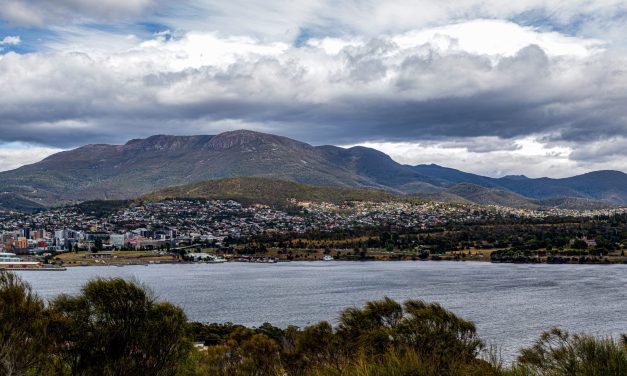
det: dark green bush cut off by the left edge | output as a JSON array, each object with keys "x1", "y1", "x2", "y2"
[{"x1": 0, "y1": 271, "x2": 53, "y2": 376}]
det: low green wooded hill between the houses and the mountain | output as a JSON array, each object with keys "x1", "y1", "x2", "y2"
[{"x1": 139, "y1": 177, "x2": 396, "y2": 207}]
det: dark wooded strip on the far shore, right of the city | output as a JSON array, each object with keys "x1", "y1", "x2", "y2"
[{"x1": 237, "y1": 214, "x2": 627, "y2": 255}]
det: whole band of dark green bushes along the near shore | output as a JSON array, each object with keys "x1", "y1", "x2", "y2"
[{"x1": 0, "y1": 272, "x2": 627, "y2": 376}]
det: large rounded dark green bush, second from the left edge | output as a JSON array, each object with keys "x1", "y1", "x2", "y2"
[{"x1": 52, "y1": 278, "x2": 191, "y2": 375}]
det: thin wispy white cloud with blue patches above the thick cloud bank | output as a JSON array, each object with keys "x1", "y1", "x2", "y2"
[{"x1": 0, "y1": 0, "x2": 627, "y2": 45}]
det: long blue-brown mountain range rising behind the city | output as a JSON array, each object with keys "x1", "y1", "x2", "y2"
[{"x1": 0, "y1": 130, "x2": 627, "y2": 209}]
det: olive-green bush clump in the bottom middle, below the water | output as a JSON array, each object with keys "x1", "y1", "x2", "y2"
[{"x1": 189, "y1": 298, "x2": 492, "y2": 376}]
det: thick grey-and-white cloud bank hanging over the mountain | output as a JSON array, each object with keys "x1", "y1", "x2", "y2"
[{"x1": 0, "y1": 18, "x2": 627, "y2": 175}]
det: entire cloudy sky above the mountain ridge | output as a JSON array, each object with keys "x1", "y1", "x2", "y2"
[{"x1": 0, "y1": 0, "x2": 627, "y2": 177}]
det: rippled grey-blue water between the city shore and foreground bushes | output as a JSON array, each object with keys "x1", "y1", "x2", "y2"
[{"x1": 14, "y1": 261, "x2": 627, "y2": 359}]
